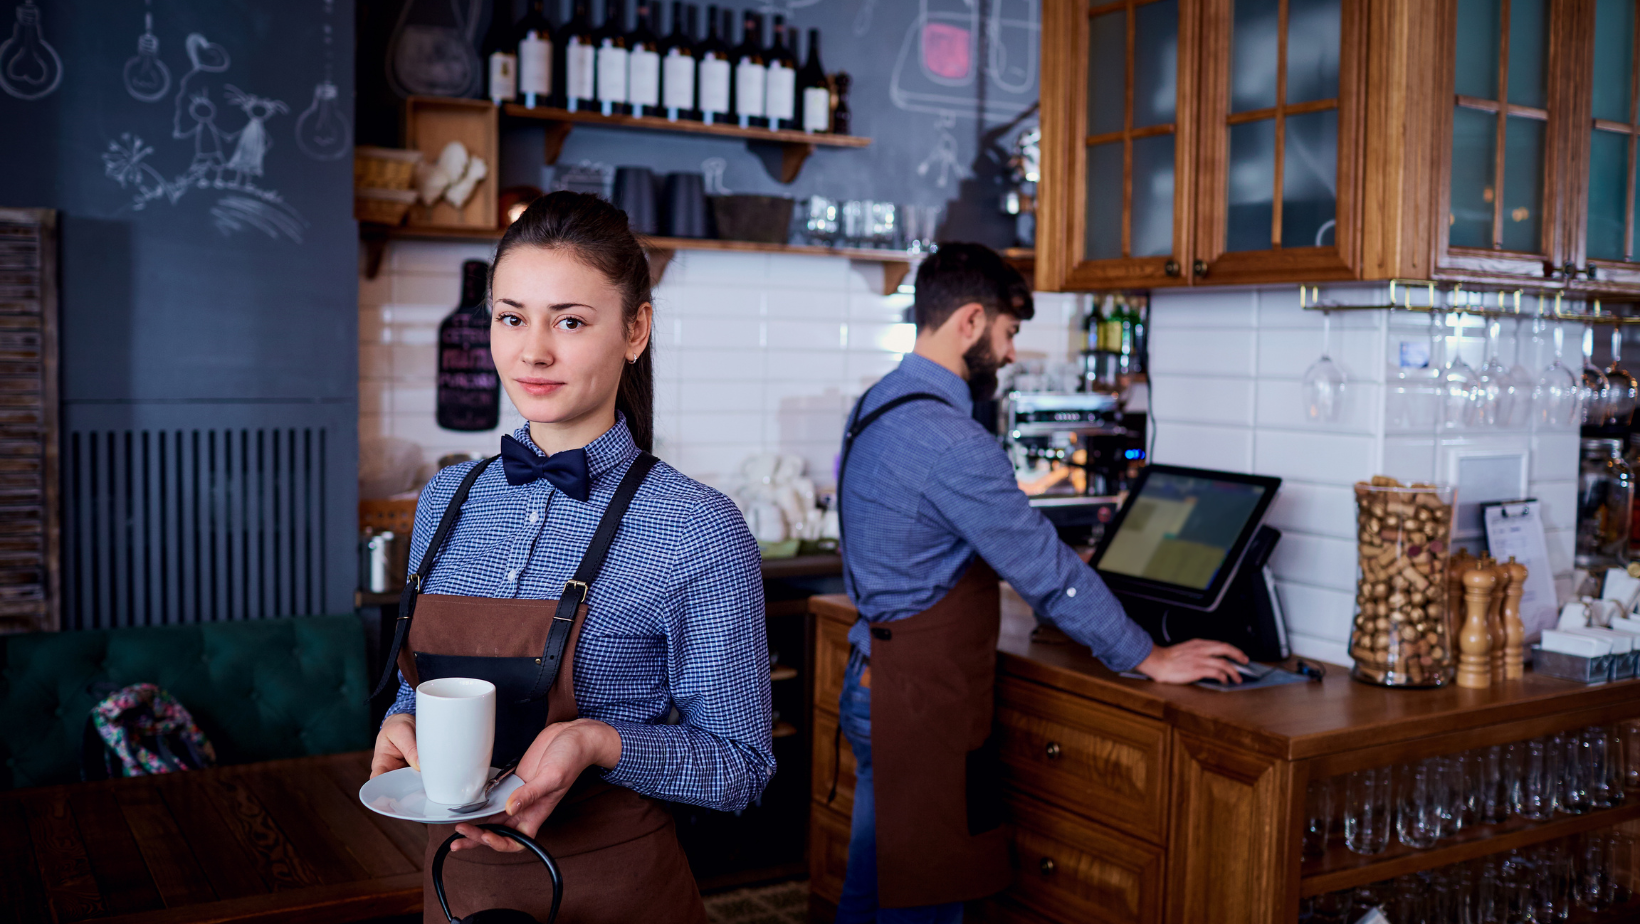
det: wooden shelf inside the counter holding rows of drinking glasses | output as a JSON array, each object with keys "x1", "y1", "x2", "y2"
[{"x1": 1299, "y1": 793, "x2": 1640, "y2": 896}]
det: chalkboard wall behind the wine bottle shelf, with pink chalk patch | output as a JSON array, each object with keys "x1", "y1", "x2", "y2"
[{"x1": 358, "y1": 0, "x2": 1040, "y2": 246}]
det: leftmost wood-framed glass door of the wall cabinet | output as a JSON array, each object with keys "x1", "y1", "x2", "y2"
[{"x1": 1038, "y1": 0, "x2": 1197, "y2": 289}]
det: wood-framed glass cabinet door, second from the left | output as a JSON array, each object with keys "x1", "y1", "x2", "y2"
[{"x1": 1194, "y1": 0, "x2": 1361, "y2": 282}]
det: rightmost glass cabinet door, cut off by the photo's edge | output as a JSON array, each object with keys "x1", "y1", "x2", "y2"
[{"x1": 1563, "y1": 0, "x2": 1640, "y2": 287}]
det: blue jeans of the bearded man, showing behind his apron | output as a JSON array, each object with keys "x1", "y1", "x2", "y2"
[{"x1": 836, "y1": 652, "x2": 963, "y2": 924}]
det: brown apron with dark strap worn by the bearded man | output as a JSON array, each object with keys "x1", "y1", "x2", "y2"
[{"x1": 838, "y1": 392, "x2": 1014, "y2": 908}]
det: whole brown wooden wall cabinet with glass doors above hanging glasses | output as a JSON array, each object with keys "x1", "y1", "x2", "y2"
[{"x1": 1036, "y1": 0, "x2": 1640, "y2": 294}]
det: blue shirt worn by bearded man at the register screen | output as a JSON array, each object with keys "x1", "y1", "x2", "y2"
[{"x1": 843, "y1": 353, "x2": 1151, "y2": 671}]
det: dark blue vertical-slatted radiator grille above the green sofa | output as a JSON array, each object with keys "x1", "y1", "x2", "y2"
[{"x1": 62, "y1": 427, "x2": 328, "y2": 629}]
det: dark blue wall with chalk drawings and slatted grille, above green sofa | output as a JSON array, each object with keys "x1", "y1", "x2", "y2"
[{"x1": 0, "y1": 0, "x2": 358, "y2": 625}]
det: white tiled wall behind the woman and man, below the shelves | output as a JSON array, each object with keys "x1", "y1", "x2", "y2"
[{"x1": 359, "y1": 241, "x2": 1081, "y2": 487}]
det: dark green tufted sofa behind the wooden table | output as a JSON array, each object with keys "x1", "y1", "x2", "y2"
[{"x1": 0, "y1": 614, "x2": 371, "y2": 789}]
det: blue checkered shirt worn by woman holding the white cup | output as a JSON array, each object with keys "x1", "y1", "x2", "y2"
[{"x1": 389, "y1": 420, "x2": 774, "y2": 811}]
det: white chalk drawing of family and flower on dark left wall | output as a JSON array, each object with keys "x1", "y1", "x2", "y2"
[{"x1": 103, "y1": 33, "x2": 307, "y2": 243}]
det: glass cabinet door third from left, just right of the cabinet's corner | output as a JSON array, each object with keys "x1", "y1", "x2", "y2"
[{"x1": 1438, "y1": 0, "x2": 1563, "y2": 279}]
